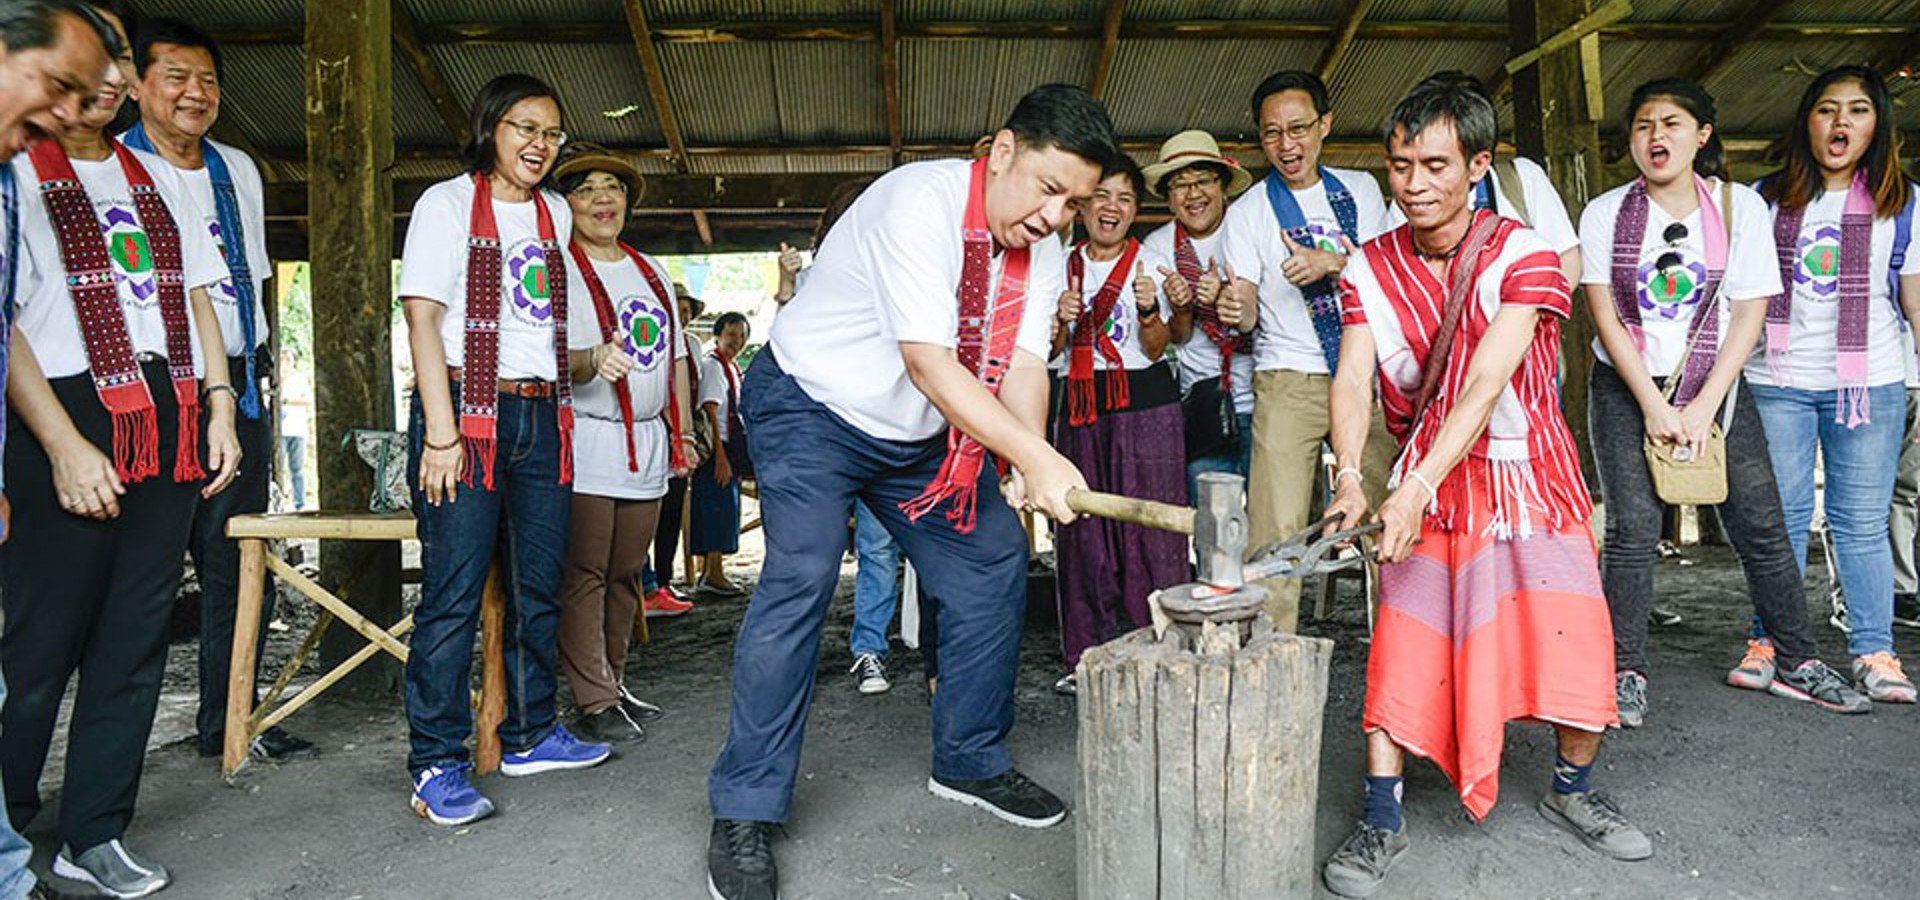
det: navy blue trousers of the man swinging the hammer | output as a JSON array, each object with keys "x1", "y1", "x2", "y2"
[{"x1": 707, "y1": 349, "x2": 1027, "y2": 821}]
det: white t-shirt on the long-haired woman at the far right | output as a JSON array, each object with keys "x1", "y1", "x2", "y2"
[{"x1": 1745, "y1": 190, "x2": 1920, "y2": 391}]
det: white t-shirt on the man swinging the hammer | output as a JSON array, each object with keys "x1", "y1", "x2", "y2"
[{"x1": 768, "y1": 159, "x2": 1066, "y2": 441}]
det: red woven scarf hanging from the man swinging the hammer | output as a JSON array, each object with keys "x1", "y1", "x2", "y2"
[{"x1": 900, "y1": 157, "x2": 1029, "y2": 533}]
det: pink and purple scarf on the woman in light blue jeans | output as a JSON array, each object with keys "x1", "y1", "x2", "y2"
[{"x1": 1766, "y1": 169, "x2": 1874, "y2": 428}]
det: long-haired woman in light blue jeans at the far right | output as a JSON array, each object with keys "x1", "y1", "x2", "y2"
[{"x1": 1747, "y1": 65, "x2": 1920, "y2": 702}]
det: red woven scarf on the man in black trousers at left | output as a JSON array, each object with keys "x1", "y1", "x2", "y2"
[{"x1": 29, "y1": 138, "x2": 205, "y2": 482}]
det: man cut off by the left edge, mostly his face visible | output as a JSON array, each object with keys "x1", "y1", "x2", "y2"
[{"x1": 0, "y1": 0, "x2": 121, "y2": 900}]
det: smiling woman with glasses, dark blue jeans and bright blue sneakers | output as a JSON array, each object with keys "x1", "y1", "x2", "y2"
[{"x1": 399, "y1": 75, "x2": 611, "y2": 825}]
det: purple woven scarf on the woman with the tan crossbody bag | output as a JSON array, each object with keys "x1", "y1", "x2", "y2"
[{"x1": 1611, "y1": 175, "x2": 1728, "y2": 409}]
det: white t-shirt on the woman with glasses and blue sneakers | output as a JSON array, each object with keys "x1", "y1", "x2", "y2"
[{"x1": 399, "y1": 175, "x2": 574, "y2": 382}]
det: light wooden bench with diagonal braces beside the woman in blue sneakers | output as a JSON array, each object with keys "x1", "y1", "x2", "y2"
[{"x1": 221, "y1": 512, "x2": 507, "y2": 781}]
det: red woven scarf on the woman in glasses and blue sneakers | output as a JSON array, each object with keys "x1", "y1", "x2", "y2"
[{"x1": 461, "y1": 173, "x2": 572, "y2": 491}]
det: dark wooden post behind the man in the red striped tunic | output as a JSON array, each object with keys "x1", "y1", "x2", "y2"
[{"x1": 1507, "y1": 0, "x2": 1605, "y2": 472}]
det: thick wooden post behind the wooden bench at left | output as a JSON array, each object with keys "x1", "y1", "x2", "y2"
[{"x1": 305, "y1": 0, "x2": 401, "y2": 695}]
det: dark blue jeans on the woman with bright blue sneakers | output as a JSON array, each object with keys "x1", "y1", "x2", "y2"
[{"x1": 405, "y1": 384, "x2": 572, "y2": 775}]
